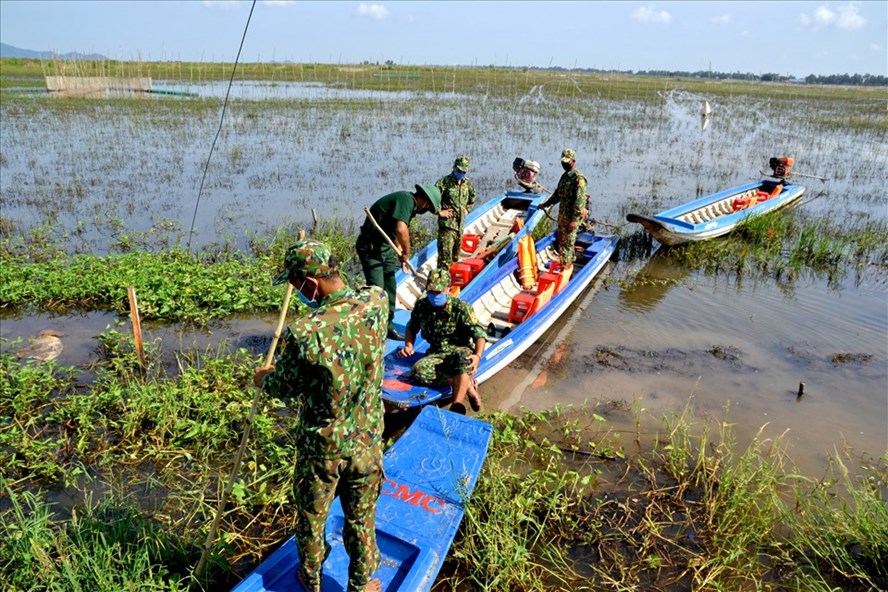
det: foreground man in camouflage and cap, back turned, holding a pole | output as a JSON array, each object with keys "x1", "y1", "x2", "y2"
[{"x1": 254, "y1": 240, "x2": 388, "y2": 592}]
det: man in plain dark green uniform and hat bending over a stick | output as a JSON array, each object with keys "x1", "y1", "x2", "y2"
[{"x1": 355, "y1": 185, "x2": 441, "y2": 341}]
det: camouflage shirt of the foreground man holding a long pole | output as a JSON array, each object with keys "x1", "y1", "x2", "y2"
[{"x1": 262, "y1": 286, "x2": 388, "y2": 458}]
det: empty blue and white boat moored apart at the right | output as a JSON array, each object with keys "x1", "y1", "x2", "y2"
[{"x1": 626, "y1": 178, "x2": 805, "y2": 246}]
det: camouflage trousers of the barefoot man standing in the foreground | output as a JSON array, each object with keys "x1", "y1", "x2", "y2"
[{"x1": 293, "y1": 445, "x2": 384, "y2": 592}]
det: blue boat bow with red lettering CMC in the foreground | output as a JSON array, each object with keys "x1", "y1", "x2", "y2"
[{"x1": 232, "y1": 406, "x2": 493, "y2": 592}]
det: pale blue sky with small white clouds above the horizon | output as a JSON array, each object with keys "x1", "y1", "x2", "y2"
[{"x1": 0, "y1": 0, "x2": 888, "y2": 77}]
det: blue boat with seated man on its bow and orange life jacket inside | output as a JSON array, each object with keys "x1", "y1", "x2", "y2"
[{"x1": 382, "y1": 230, "x2": 619, "y2": 412}]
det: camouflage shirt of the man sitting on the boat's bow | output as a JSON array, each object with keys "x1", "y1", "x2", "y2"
[{"x1": 407, "y1": 297, "x2": 487, "y2": 351}]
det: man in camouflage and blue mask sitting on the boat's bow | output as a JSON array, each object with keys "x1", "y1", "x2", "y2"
[{"x1": 398, "y1": 269, "x2": 487, "y2": 414}]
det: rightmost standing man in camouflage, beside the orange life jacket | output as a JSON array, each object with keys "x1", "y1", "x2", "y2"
[{"x1": 541, "y1": 148, "x2": 589, "y2": 267}]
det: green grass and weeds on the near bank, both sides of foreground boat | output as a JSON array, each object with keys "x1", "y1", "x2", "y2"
[{"x1": 0, "y1": 340, "x2": 888, "y2": 592}]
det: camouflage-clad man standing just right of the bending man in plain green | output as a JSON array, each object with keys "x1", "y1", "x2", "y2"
[{"x1": 435, "y1": 156, "x2": 475, "y2": 270}]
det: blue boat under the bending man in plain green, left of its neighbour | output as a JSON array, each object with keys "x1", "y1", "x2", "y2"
[{"x1": 387, "y1": 191, "x2": 549, "y2": 338}]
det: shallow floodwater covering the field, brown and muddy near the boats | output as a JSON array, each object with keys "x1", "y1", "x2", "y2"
[{"x1": 0, "y1": 84, "x2": 888, "y2": 474}]
